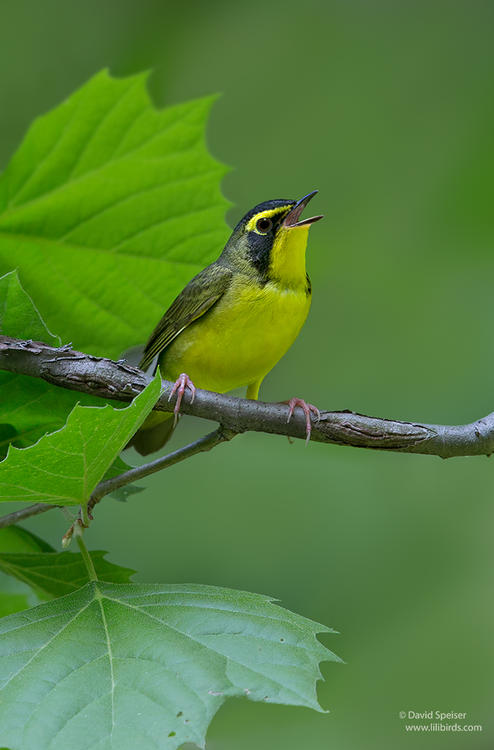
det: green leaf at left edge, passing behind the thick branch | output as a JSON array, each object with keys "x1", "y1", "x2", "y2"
[{"x1": 0, "y1": 271, "x2": 109, "y2": 458}]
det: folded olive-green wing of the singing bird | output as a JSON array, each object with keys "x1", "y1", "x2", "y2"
[{"x1": 139, "y1": 263, "x2": 233, "y2": 370}]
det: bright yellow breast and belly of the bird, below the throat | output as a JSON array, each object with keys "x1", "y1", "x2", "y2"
[{"x1": 160, "y1": 284, "x2": 310, "y2": 393}]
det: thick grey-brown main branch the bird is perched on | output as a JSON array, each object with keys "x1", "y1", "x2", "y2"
[{"x1": 0, "y1": 336, "x2": 494, "y2": 458}]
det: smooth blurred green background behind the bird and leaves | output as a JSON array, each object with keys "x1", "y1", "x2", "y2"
[{"x1": 0, "y1": 0, "x2": 494, "y2": 750}]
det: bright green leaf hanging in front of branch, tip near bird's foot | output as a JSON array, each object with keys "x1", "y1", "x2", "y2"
[{"x1": 0, "y1": 378, "x2": 161, "y2": 505}]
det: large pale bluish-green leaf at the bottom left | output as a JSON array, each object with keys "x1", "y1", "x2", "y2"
[{"x1": 0, "y1": 583, "x2": 339, "y2": 750}]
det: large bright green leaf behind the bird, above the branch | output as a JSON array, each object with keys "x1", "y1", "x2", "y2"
[{"x1": 0, "y1": 71, "x2": 228, "y2": 357}]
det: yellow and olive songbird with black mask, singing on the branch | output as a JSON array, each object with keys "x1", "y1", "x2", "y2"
[{"x1": 128, "y1": 190, "x2": 323, "y2": 455}]
